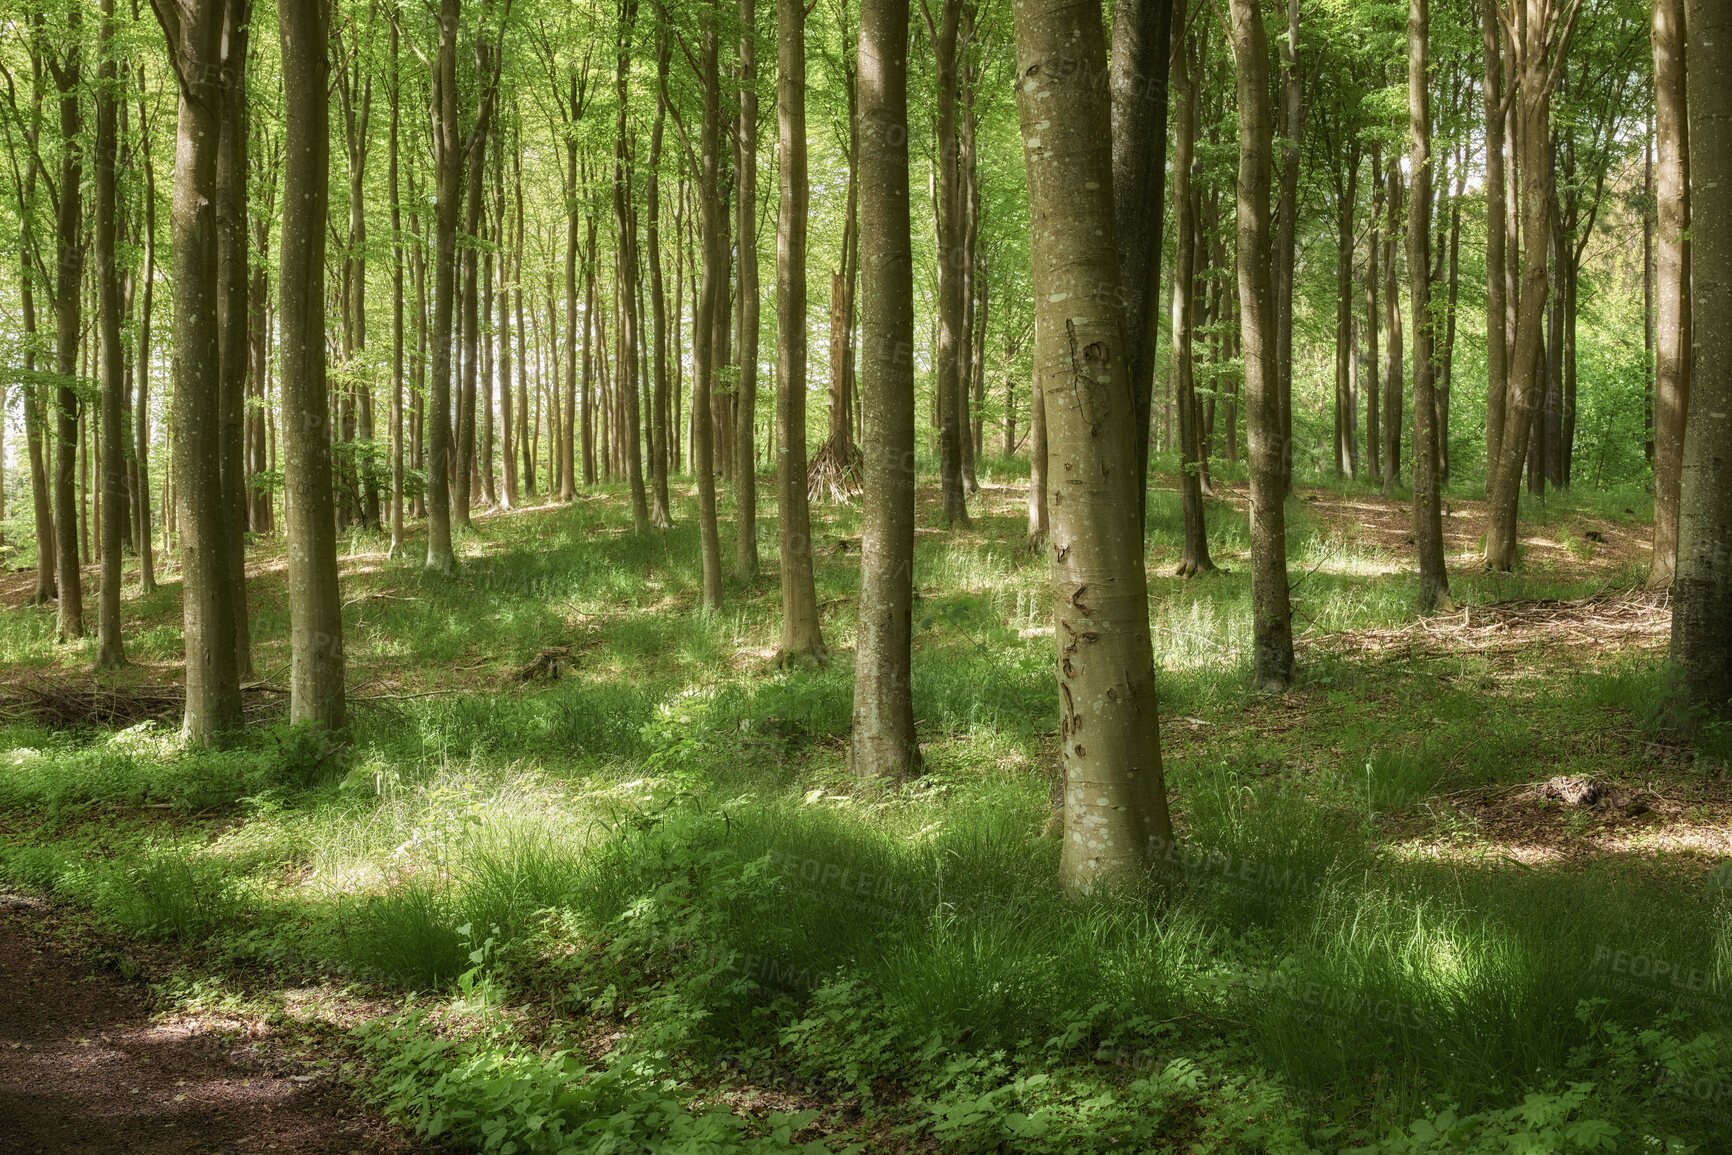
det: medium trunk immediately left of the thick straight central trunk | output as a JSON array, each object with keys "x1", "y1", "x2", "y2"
[{"x1": 776, "y1": 0, "x2": 824, "y2": 663}]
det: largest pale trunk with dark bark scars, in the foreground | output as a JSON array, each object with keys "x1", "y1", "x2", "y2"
[{"x1": 1015, "y1": 0, "x2": 1174, "y2": 894}]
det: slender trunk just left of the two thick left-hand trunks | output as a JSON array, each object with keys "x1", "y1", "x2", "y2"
[{"x1": 95, "y1": 0, "x2": 126, "y2": 668}]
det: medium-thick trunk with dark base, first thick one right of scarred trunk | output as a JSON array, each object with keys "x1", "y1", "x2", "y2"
[{"x1": 1231, "y1": 0, "x2": 1294, "y2": 689}]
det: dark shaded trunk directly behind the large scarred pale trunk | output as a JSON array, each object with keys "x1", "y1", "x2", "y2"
[{"x1": 1110, "y1": 0, "x2": 1173, "y2": 525}]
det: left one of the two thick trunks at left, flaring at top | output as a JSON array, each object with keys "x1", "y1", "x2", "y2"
[{"x1": 153, "y1": 0, "x2": 241, "y2": 741}]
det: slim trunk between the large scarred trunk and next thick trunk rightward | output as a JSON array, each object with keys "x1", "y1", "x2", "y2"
[{"x1": 1170, "y1": 0, "x2": 1214, "y2": 577}]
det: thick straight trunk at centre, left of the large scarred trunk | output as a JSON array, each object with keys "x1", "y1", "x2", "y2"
[{"x1": 849, "y1": 0, "x2": 920, "y2": 778}]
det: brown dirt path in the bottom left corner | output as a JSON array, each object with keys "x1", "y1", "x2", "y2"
[{"x1": 0, "y1": 894, "x2": 421, "y2": 1155}]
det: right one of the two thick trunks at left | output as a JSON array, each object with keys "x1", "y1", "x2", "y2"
[{"x1": 277, "y1": 0, "x2": 344, "y2": 729}]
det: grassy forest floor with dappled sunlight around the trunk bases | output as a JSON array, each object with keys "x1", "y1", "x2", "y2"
[{"x1": 0, "y1": 461, "x2": 1732, "y2": 1155}]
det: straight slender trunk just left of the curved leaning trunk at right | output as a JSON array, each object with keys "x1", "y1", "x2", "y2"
[{"x1": 1408, "y1": 0, "x2": 1450, "y2": 613}]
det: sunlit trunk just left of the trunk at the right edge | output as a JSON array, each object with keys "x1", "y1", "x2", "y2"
[{"x1": 1647, "y1": 0, "x2": 1706, "y2": 589}]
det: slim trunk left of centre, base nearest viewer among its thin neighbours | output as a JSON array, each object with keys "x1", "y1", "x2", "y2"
[{"x1": 691, "y1": 0, "x2": 727, "y2": 613}]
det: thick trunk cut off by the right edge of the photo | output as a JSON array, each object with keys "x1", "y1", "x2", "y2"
[{"x1": 1656, "y1": 0, "x2": 1732, "y2": 722}]
